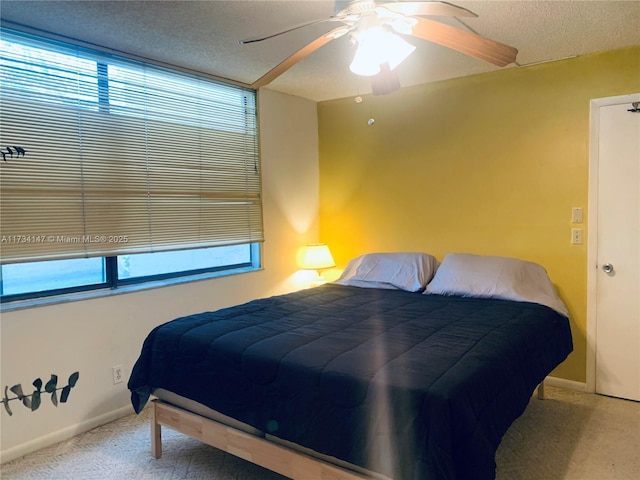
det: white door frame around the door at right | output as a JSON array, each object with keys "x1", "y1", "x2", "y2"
[{"x1": 585, "y1": 93, "x2": 640, "y2": 393}]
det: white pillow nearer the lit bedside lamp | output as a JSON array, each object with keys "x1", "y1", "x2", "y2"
[{"x1": 334, "y1": 252, "x2": 438, "y2": 292}]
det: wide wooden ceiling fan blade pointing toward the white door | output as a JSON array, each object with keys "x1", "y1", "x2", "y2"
[{"x1": 411, "y1": 17, "x2": 518, "y2": 67}]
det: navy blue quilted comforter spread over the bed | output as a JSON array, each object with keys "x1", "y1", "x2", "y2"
[{"x1": 129, "y1": 285, "x2": 572, "y2": 480}]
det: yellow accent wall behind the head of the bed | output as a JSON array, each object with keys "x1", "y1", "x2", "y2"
[{"x1": 318, "y1": 47, "x2": 640, "y2": 382}]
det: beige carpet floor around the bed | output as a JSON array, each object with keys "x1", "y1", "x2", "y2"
[{"x1": 0, "y1": 387, "x2": 640, "y2": 480}]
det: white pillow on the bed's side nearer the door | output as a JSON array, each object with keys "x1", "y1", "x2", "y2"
[{"x1": 424, "y1": 253, "x2": 569, "y2": 317}]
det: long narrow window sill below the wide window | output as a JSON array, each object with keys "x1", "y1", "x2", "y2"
[{"x1": 0, "y1": 267, "x2": 263, "y2": 313}]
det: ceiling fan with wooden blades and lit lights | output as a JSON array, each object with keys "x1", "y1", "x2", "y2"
[{"x1": 240, "y1": 0, "x2": 518, "y2": 94}]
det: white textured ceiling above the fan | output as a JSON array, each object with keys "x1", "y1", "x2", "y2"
[{"x1": 0, "y1": 0, "x2": 640, "y2": 101}]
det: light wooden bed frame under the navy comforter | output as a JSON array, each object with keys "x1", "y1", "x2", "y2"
[{"x1": 151, "y1": 382, "x2": 544, "y2": 480}]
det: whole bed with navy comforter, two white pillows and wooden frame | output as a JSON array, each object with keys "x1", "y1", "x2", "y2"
[{"x1": 129, "y1": 253, "x2": 572, "y2": 480}]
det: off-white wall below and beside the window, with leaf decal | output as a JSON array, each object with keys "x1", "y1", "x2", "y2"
[{"x1": 0, "y1": 90, "x2": 318, "y2": 461}]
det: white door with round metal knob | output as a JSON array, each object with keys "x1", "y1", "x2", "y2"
[{"x1": 595, "y1": 99, "x2": 640, "y2": 401}]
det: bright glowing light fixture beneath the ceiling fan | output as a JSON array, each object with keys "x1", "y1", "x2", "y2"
[{"x1": 349, "y1": 25, "x2": 416, "y2": 77}]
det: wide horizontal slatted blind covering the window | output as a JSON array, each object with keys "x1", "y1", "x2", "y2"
[{"x1": 0, "y1": 30, "x2": 264, "y2": 263}]
